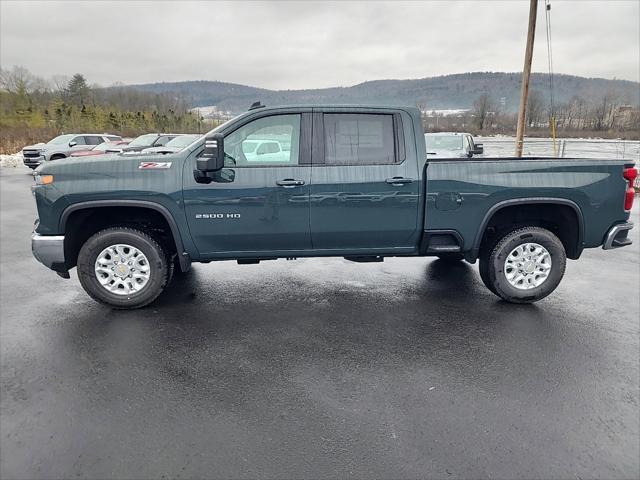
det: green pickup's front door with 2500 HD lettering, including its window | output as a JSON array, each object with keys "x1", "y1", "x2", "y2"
[{"x1": 184, "y1": 114, "x2": 311, "y2": 258}]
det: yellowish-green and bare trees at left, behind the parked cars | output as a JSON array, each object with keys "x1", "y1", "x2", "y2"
[{"x1": 0, "y1": 67, "x2": 212, "y2": 153}]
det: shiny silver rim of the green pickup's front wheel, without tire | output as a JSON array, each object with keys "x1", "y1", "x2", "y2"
[{"x1": 94, "y1": 244, "x2": 151, "y2": 295}]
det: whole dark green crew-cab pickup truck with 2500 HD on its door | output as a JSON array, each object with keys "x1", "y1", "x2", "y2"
[{"x1": 32, "y1": 106, "x2": 637, "y2": 308}]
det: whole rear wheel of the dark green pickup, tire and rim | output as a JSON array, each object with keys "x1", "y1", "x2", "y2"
[{"x1": 480, "y1": 227, "x2": 567, "y2": 303}]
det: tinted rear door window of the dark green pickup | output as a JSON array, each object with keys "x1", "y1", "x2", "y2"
[{"x1": 324, "y1": 113, "x2": 396, "y2": 165}]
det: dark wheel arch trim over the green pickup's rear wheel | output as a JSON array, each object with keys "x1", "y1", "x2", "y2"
[{"x1": 471, "y1": 197, "x2": 584, "y2": 259}]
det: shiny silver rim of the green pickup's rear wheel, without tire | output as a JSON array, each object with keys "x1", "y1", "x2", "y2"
[{"x1": 504, "y1": 243, "x2": 551, "y2": 290}]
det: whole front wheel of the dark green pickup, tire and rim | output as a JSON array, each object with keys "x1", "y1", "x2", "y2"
[{"x1": 78, "y1": 227, "x2": 169, "y2": 309}]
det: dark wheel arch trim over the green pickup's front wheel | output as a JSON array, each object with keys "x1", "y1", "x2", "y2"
[{"x1": 59, "y1": 200, "x2": 191, "y2": 272}]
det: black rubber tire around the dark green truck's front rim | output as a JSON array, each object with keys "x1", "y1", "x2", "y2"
[{"x1": 78, "y1": 227, "x2": 170, "y2": 309}]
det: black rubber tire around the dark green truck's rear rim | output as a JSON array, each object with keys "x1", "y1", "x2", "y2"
[{"x1": 480, "y1": 227, "x2": 567, "y2": 303}]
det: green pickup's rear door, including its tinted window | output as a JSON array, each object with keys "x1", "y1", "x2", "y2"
[{"x1": 309, "y1": 109, "x2": 420, "y2": 253}]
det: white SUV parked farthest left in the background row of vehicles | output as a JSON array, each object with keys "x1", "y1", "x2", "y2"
[{"x1": 22, "y1": 133, "x2": 122, "y2": 168}]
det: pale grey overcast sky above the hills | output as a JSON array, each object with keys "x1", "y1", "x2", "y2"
[{"x1": 0, "y1": 0, "x2": 640, "y2": 89}]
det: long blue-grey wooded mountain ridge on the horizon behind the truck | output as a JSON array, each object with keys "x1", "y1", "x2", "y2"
[{"x1": 126, "y1": 72, "x2": 640, "y2": 113}]
